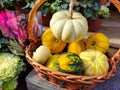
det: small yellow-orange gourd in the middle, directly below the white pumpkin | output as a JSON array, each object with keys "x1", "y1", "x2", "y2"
[{"x1": 67, "y1": 40, "x2": 85, "y2": 55}]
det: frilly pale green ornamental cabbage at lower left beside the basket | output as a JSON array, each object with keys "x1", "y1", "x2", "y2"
[{"x1": 0, "y1": 53, "x2": 25, "y2": 90}]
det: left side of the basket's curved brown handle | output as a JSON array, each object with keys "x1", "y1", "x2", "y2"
[{"x1": 28, "y1": 0, "x2": 45, "y2": 42}]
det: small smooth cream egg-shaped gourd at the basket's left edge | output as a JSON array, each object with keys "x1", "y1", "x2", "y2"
[{"x1": 32, "y1": 45, "x2": 51, "y2": 64}]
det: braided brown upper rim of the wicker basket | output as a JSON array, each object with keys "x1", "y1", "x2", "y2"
[{"x1": 25, "y1": 44, "x2": 119, "y2": 80}]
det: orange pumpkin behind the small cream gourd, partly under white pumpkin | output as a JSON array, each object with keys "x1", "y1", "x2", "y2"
[{"x1": 42, "y1": 28, "x2": 66, "y2": 53}]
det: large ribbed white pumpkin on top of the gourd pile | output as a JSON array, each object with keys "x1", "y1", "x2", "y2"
[{"x1": 50, "y1": 10, "x2": 88, "y2": 42}]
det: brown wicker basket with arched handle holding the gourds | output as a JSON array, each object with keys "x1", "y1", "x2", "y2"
[{"x1": 25, "y1": 0, "x2": 120, "y2": 90}]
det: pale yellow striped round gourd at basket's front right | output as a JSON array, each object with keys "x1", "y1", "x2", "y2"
[{"x1": 79, "y1": 49, "x2": 109, "y2": 76}]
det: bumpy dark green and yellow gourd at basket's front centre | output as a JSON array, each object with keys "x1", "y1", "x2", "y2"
[{"x1": 58, "y1": 52, "x2": 83, "y2": 74}]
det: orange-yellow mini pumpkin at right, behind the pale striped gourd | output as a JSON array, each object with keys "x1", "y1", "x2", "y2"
[{"x1": 86, "y1": 33, "x2": 109, "y2": 53}]
